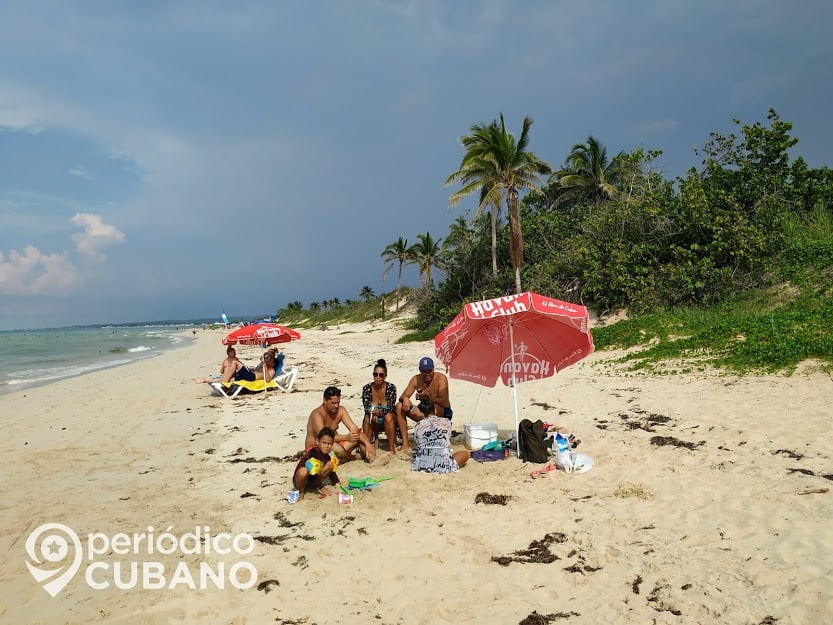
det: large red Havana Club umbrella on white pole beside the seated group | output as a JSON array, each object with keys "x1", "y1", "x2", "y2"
[{"x1": 434, "y1": 292, "x2": 593, "y2": 454}]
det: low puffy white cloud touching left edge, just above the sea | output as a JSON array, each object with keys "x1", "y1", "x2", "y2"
[{"x1": 0, "y1": 245, "x2": 79, "y2": 295}]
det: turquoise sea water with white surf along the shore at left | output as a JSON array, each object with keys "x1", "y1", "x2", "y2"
[{"x1": 0, "y1": 320, "x2": 205, "y2": 394}]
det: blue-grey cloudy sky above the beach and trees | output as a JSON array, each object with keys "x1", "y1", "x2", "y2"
[{"x1": 0, "y1": 0, "x2": 833, "y2": 330}]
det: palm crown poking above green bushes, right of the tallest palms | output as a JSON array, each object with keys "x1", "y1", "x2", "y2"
[{"x1": 550, "y1": 135, "x2": 625, "y2": 204}]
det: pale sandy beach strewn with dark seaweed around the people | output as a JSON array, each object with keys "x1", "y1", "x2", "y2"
[{"x1": 0, "y1": 322, "x2": 833, "y2": 625}]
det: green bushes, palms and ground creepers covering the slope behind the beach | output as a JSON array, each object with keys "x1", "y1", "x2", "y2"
[{"x1": 281, "y1": 110, "x2": 833, "y2": 372}]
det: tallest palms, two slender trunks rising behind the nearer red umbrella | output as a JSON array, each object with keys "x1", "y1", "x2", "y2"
[{"x1": 445, "y1": 114, "x2": 552, "y2": 293}]
